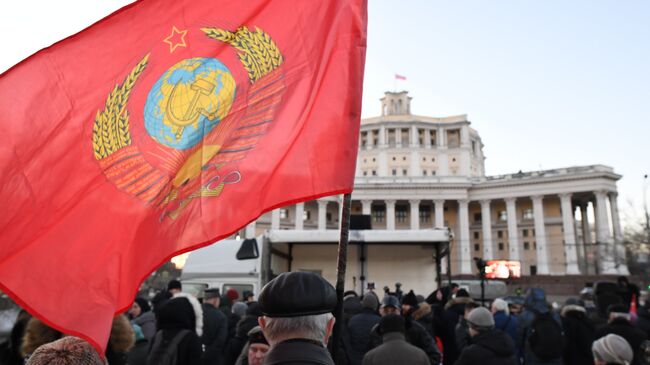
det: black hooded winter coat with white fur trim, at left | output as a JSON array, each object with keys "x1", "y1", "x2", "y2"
[{"x1": 148, "y1": 297, "x2": 203, "y2": 365}]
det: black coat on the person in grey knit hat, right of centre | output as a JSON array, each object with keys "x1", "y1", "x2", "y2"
[{"x1": 455, "y1": 329, "x2": 519, "y2": 365}]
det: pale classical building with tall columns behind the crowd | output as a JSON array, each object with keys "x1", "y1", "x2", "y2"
[{"x1": 240, "y1": 91, "x2": 628, "y2": 292}]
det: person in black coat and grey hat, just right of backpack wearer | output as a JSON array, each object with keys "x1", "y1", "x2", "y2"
[{"x1": 561, "y1": 298, "x2": 596, "y2": 365}]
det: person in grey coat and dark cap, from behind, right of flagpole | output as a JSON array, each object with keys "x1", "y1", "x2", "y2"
[{"x1": 362, "y1": 314, "x2": 429, "y2": 365}]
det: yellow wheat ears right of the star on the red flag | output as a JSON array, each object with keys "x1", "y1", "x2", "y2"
[{"x1": 201, "y1": 26, "x2": 284, "y2": 84}]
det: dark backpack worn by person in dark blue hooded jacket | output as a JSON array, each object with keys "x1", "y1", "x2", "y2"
[{"x1": 528, "y1": 312, "x2": 564, "y2": 361}]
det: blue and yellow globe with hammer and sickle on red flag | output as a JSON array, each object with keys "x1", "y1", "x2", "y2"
[{"x1": 144, "y1": 58, "x2": 236, "y2": 150}]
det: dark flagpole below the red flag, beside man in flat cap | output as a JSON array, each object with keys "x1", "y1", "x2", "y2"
[{"x1": 331, "y1": 193, "x2": 352, "y2": 361}]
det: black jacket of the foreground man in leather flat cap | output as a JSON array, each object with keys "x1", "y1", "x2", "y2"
[{"x1": 264, "y1": 339, "x2": 334, "y2": 365}]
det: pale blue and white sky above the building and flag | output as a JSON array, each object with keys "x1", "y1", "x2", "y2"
[{"x1": 0, "y1": 0, "x2": 650, "y2": 228}]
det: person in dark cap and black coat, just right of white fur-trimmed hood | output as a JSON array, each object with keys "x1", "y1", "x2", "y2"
[{"x1": 201, "y1": 288, "x2": 229, "y2": 365}]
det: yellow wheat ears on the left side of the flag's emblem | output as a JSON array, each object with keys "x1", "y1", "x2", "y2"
[{"x1": 93, "y1": 55, "x2": 149, "y2": 160}]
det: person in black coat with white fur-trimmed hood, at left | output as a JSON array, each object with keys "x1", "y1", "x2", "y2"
[{"x1": 147, "y1": 293, "x2": 203, "y2": 365}]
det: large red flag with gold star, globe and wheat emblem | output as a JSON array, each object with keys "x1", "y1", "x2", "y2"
[{"x1": 0, "y1": 0, "x2": 367, "y2": 350}]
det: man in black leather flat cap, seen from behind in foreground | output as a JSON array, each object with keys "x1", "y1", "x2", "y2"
[{"x1": 258, "y1": 272, "x2": 337, "y2": 365}]
